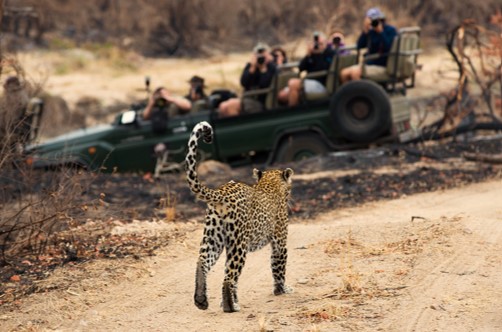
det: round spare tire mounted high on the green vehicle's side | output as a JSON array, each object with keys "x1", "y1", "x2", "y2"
[{"x1": 329, "y1": 80, "x2": 391, "y2": 143}]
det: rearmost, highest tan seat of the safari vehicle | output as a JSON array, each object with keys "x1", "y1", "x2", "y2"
[{"x1": 362, "y1": 27, "x2": 421, "y2": 90}]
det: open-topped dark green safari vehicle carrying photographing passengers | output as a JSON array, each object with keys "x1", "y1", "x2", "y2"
[{"x1": 28, "y1": 28, "x2": 420, "y2": 175}]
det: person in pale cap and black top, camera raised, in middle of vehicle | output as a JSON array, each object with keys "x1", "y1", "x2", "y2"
[{"x1": 219, "y1": 43, "x2": 277, "y2": 117}]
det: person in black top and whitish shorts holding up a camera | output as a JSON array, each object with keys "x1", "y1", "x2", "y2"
[{"x1": 278, "y1": 31, "x2": 334, "y2": 106}]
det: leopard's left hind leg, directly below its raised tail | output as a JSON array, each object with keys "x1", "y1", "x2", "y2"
[{"x1": 194, "y1": 211, "x2": 224, "y2": 310}]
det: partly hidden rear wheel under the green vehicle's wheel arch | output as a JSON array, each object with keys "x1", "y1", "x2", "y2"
[{"x1": 274, "y1": 133, "x2": 329, "y2": 163}]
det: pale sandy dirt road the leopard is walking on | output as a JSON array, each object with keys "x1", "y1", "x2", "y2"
[{"x1": 0, "y1": 180, "x2": 502, "y2": 332}]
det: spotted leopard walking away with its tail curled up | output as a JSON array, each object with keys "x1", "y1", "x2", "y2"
[{"x1": 185, "y1": 121, "x2": 294, "y2": 312}]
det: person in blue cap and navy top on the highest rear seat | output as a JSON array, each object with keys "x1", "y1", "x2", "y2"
[{"x1": 340, "y1": 7, "x2": 397, "y2": 83}]
